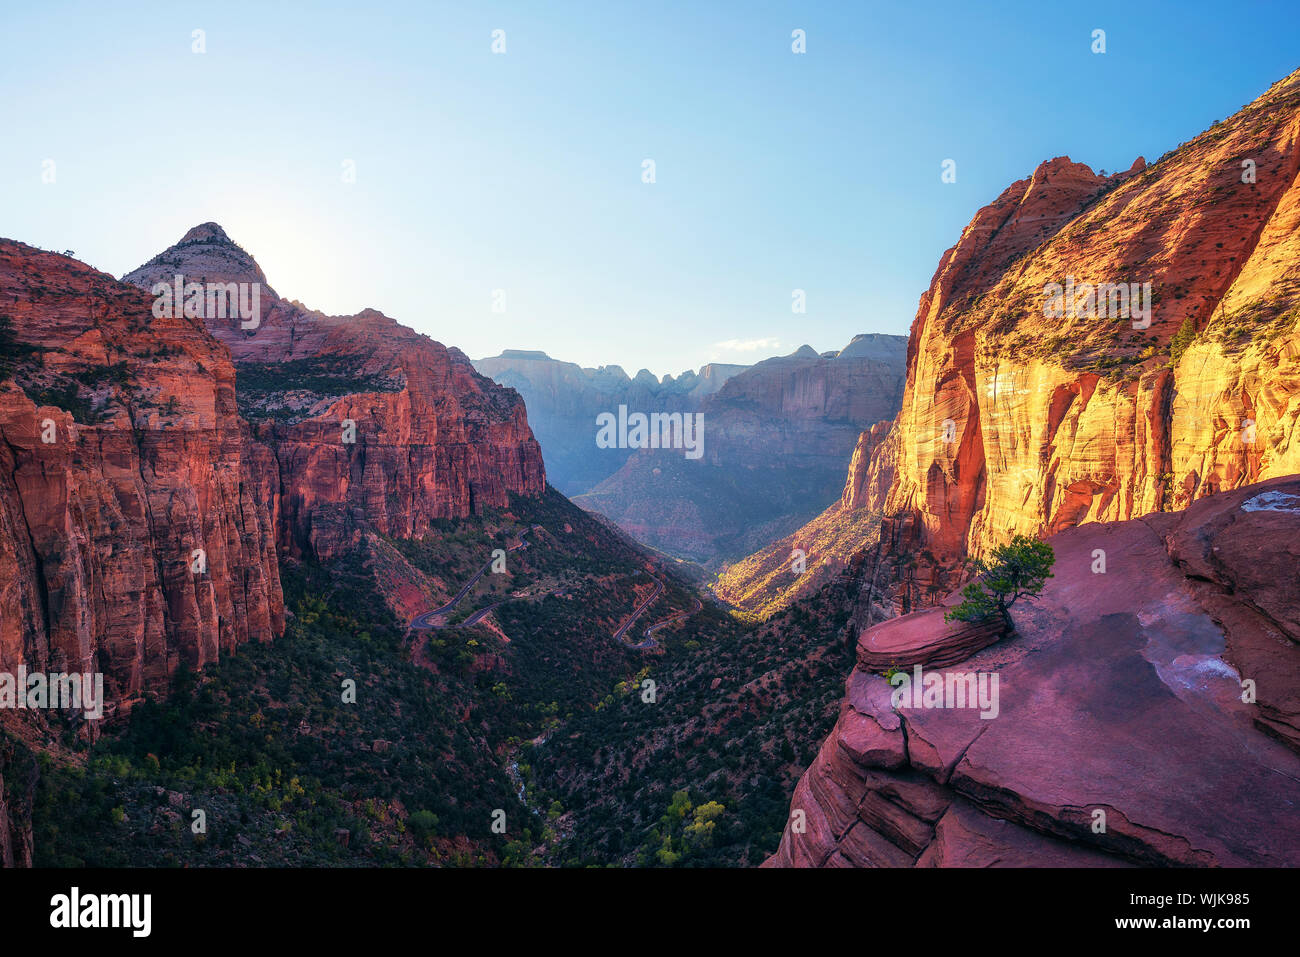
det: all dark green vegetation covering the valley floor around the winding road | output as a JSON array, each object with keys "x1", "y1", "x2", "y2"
[{"x1": 25, "y1": 492, "x2": 855, "y2": 867}]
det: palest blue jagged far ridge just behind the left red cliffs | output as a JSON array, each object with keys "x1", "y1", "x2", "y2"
[{"x1": 475, "y1": 348, "x2": 748, "y2": 495}]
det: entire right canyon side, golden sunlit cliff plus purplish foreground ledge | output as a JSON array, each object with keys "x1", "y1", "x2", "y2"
[{"x1": 759, "y1": 72, "x2": 1300, "y2": 867}]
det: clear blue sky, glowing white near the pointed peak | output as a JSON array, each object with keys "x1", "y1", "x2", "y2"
[{"x1": 0, "y1": 0, "x2": 1300, "y2": 374}]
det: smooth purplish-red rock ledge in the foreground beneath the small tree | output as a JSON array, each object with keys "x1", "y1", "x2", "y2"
[{"x1": 766, "y1": 477, "x2": 1300, "y2": 866}]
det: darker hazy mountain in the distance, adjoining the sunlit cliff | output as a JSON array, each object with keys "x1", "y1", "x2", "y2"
[{"x1": 575, "y1": 335, "x2": 905, "y2": 563}]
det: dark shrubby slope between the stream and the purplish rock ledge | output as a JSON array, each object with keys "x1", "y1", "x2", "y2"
[{"x1": 524, "y1": 566, "x2": 857, "y2": 867}]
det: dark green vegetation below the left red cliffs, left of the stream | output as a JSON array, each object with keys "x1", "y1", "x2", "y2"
[{"x1": 34, "y1": 553, "x2": 542, "y2": 866}]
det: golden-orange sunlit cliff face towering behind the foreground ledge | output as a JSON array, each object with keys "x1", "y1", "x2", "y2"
[{"x1": 868, "y1": 73, "x2": 1300, "y2": 582}]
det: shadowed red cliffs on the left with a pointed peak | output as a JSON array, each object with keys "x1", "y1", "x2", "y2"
[{"x1": 0, "y1": 224, "x2": 546, "y2": 713}]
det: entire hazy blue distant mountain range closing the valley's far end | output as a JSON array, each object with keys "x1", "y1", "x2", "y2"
[{"x1": 475, "y1": 334, "x2": 906, "y2": 564}]
